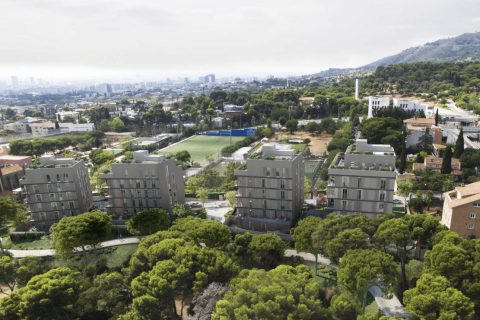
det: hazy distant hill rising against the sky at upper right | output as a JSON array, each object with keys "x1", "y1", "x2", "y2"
[{"x1": 362, "y1": 32, "x2": 480, "y2": 69}]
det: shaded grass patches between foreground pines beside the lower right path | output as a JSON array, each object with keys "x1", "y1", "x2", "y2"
[{"x1": 305, "y1": 261, "x2": 380, "y2": 313}]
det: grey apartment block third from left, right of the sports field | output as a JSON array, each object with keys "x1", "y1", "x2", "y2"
[{"x1": 234, "y1": 144, "x2": 305, "y2": 231}]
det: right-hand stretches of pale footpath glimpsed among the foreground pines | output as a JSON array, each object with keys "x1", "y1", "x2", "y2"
[{"x1": 285, "y1": 250, "x2": 411, "y2": 318}]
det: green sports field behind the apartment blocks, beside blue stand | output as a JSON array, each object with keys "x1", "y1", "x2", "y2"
[{"x1": 159, "y1": 136, "x2": 245, "y2": 164}]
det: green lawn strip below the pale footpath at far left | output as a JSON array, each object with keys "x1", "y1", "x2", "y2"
[{"x1": 50, "y1": 243, "x2": 138, "y2": 269}]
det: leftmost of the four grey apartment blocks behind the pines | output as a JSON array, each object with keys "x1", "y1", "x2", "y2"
[{"x1": 20, "y1": 155, "x2": 93, "y2": 231}]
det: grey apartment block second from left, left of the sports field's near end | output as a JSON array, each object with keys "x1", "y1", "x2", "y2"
[{"x1": 100, "y1": 150, "x2": 185, "y2": 218}]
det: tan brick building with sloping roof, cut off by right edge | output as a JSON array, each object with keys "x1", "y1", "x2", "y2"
[{"x1": 441, "y1": 182, "x2": 480, "y2": 239}]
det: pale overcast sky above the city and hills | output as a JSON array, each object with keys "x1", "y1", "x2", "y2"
[{"x1": 0, "y1": 0, "x2": 480, "y2": 78}]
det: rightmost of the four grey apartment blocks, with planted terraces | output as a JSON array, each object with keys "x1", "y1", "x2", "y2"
[{"x1": 327, "y1": 139, "x2": 396, "y2": 218}]
